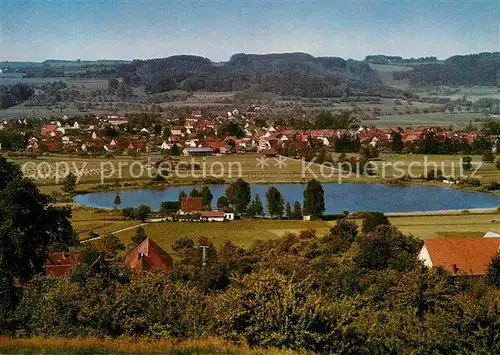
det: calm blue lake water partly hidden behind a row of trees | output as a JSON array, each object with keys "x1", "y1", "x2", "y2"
[{"x1": 74, "y1": 183, "x2": 500, "y2": 213}]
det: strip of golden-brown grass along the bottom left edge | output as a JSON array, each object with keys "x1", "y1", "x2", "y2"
[{"x1": 0, "y1": 337, "x2": 295, "y2": 355}]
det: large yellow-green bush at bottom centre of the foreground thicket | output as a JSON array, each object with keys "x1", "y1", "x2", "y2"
[{"x1": 211, "y1": 270, "x2": 362, "y2": 353}]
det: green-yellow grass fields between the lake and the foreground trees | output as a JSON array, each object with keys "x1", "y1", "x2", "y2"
[{"x1": 72, "y1": 208, "x2": 500, "y2": 252}]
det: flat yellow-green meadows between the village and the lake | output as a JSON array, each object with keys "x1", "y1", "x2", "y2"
[{"x1": 10, "y1": 153, "x2": 500, "y2": 194}]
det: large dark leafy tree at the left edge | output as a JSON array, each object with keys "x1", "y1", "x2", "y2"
[{"x1": 0, "y1": 157, "x2": 77, "y2": 280}]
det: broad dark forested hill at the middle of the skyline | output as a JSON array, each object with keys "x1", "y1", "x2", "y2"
[{"x1": 119, "y1": 53, "x2": 399, "y2": 97}]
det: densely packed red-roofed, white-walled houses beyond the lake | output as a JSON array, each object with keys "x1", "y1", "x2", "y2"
[{"x1": 0, "y1": 107, "x2": 496, "y2": 156}]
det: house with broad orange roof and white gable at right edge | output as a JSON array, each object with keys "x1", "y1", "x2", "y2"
[{"x1": 418, "y1": 238, "x2": 500, "y2": 275}]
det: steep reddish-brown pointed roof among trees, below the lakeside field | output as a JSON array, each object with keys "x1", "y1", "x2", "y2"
[{"x1": 125, "y1": 238, "x2": 173, "y2": 274}]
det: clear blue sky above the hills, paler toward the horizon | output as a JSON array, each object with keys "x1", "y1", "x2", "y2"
[{"x1": 0, "y1": 0, "x2": 500, "y2": 61}]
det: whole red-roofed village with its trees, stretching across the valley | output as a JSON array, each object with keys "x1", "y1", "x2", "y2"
[{"x1": 0, "y1": 106, "x2": 497, "y2": 156}]
